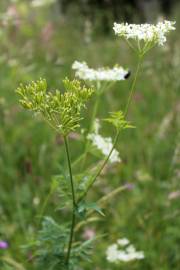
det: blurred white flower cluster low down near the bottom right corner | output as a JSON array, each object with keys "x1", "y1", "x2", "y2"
[{"x1": 106, "y1": 238, "x2": 144, "y2": 263}]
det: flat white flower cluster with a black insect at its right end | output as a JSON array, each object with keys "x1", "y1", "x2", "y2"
[{"x1": 72, "y1": 61, "x2": 129, "y2": 81}]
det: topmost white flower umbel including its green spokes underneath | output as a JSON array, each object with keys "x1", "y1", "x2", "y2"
[{"x1": 113, "y1": 20, "x2": 175, "y2": 54}]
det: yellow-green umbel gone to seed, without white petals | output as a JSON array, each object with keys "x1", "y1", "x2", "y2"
[{"x1": 16, "y1": 79, "x2": 93, "y2": 136}]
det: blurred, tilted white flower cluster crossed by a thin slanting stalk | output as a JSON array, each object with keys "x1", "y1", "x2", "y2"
[{"x1": 87, "y1": 119, "x2": 121, "y2": 163}]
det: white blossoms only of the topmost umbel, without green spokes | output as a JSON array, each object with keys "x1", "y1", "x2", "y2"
[{"x1": 113, "y1": 20, "x2": 175, "y2": 45}]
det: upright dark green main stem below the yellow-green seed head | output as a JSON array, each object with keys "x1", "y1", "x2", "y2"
[{"x1": 64, "y1": 137, "x2": 76, "y2": 266}]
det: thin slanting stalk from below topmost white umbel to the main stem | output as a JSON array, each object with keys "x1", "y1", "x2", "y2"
[{"x1": 78, "y1": 55, "x2": 143, "y2": 201}]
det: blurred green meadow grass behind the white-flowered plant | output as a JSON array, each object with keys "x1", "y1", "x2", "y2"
[{"x1": 0, "y1": 0, "x2": 180, "y2": 270}]
